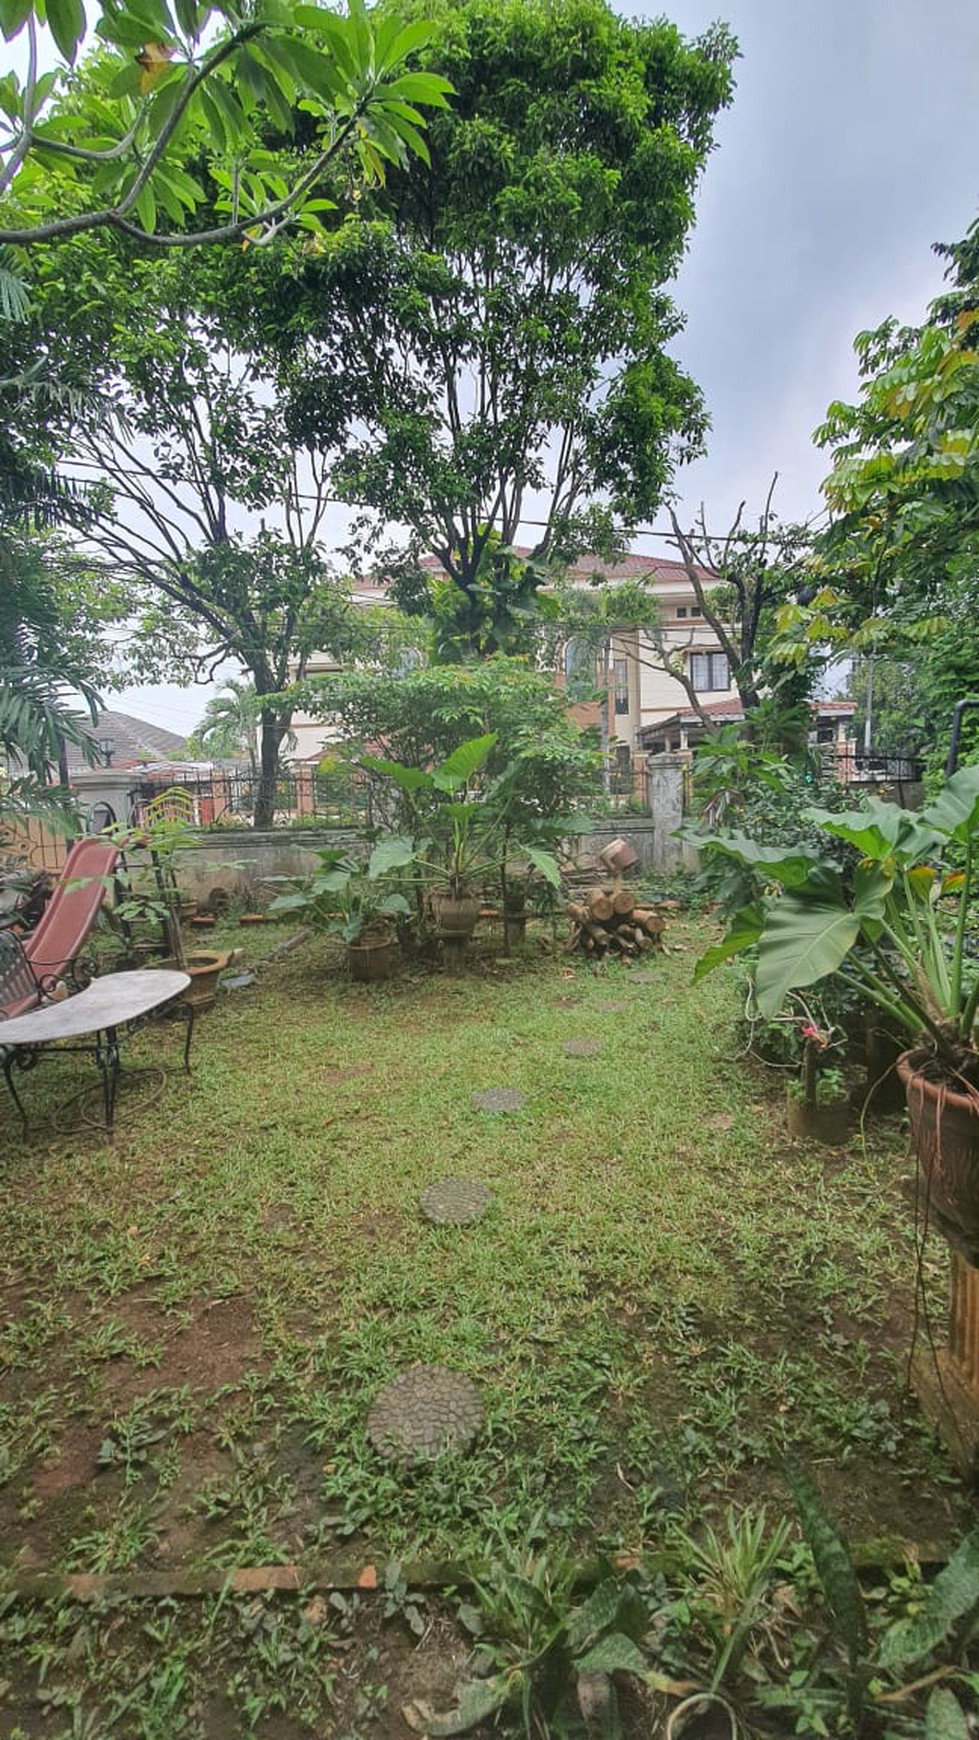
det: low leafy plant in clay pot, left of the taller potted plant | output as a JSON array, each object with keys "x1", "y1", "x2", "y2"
[{"x1": 270, "y1": 835, "x2": 414, "y2": 981}]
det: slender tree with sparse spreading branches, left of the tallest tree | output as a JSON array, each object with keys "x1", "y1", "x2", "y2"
[{"x1": 23, "y1": 235, "x2": 356, "y2": 827}]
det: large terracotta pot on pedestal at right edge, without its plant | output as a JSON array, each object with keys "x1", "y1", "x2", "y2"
[{"x1": 897, "y1": 1051, "x2": 979, "y2": 1246}]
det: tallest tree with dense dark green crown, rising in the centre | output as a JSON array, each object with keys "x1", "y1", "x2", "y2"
[{"x1": 238, "y1": 0, "x2": 734, "y2": 654}]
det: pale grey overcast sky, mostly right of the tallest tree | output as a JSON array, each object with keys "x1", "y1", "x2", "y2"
[{"x1": 113, "y1": 0, "x2": 979, "y2": 731}]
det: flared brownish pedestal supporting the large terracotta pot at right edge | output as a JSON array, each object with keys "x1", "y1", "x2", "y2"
[{"x1": 911, "y1": 1251, "x2": 979, "y2": 1484}]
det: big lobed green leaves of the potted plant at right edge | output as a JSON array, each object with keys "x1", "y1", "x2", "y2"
[{"x1": 696, "y1": 767, "x2": 979, "y2": 1084}]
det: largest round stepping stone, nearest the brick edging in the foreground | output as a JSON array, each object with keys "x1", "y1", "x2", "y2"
[{"x1": 367, "y1": 1366, "x2": 483, "y2": 1462}]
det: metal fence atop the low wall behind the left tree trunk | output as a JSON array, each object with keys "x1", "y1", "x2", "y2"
[{"x1": 132, "y1": 767, "x2": 370, "y2": 828}]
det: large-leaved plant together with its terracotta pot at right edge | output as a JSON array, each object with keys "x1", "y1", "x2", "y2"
[{"x1": 697, "y1": 767, "x2": 979, "y2": 1262}]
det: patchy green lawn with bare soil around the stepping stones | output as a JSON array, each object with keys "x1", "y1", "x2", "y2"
[{"x1": 0, "y1": 922, "x2": 960, "y2": 1735}]
